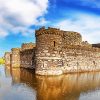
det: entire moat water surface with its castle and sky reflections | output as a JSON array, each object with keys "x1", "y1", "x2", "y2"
[{"x1": 0, "y1": 66, "x2": 100, "y2": 100}]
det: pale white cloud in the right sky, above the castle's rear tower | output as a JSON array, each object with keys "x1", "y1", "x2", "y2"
[{"x1": 55, "y1": 14, "x2": 100, "y2": 43}]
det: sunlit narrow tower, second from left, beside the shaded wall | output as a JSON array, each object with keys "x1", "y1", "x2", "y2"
[{"x1": 11, "y1": 48, "x2": 20, "y2": 67}]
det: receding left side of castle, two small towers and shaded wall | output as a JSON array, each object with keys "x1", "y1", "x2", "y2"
[{"x1": 4, "y1": 43, "x2": 35, "y2": 68}]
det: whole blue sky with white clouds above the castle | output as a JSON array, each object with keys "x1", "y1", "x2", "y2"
[{"x1": 0, "y1": 0, "x2": 100, "y2": 57}]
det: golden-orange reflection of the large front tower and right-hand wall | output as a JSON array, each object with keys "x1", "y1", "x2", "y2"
[{"x1": 37, "y1": 73, "x2": 100, "y2": 100}]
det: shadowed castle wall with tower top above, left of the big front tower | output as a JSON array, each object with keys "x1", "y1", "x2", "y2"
[{"x1": 20, "y1": 42, "x2": 35, "y2": 68}]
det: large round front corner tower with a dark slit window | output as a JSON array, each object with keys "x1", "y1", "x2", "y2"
[{"x1": 35, "y1": 27, "x2": 63, "y2": 75}]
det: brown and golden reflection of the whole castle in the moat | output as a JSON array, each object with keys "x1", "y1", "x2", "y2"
[{"x1": 5, "y1": 66, "x2": 100, "y2": 100}]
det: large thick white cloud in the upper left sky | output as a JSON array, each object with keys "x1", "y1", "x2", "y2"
[{"x1": 0, "y1": 0, "x2": 48, "y2": 37}]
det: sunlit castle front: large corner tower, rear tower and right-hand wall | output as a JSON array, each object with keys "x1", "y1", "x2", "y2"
[{"x1": 36, "y1": 27, "x2": 100, "y2": 75}]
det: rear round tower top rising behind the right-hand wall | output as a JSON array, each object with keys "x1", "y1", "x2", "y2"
[{"x1": 63, "y1": 31, "x2": 82, "y2": 46}]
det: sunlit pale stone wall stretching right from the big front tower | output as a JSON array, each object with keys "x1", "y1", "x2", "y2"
[{"x1": 62, "y1": 47, "x2": 100, "y2": 73}]
